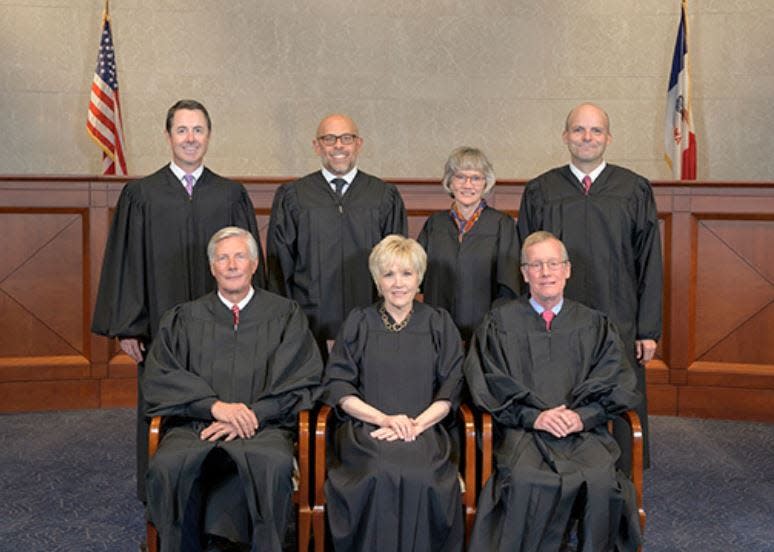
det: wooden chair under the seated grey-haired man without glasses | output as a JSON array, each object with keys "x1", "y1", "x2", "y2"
[{"x1": 146, "y1": 410, "x2": 312, "y2": 552}]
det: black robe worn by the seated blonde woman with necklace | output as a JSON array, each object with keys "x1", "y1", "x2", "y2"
[{"x1": 323, "y1": 302, "x2": 464, "y2": 552}]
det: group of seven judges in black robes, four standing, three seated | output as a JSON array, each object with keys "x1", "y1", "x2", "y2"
[{"x1": 92, "y1": 100, "x2": 662, "y2": 552}]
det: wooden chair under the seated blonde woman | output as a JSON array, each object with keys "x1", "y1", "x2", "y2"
[{"x1": 312, "y1": 404, "x2": 478, "y2": 552}]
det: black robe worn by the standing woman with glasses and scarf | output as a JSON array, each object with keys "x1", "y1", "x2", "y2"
[{"x1": 417, "y1": 207, "x2": 519, "y2": 342}]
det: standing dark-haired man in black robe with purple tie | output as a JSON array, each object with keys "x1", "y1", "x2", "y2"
[{"x1": 91, "y1": 100, "x2": 265, "y2": 501}]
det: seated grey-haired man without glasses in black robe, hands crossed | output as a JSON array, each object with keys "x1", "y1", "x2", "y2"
[{"x1": 143, "y1": 227, "x2": 322, "y2": 551}]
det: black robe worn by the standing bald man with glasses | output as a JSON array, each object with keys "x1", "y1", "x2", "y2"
[{"x1": 266, "y1": 171, "x2": 408, "y2": 343}]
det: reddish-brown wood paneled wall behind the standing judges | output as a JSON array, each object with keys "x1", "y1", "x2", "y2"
[{"x1": 0, "y1": 176, "x2": 774, "y2": 421}]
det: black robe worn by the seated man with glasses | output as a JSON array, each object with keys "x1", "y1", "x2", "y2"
[{"x1": 464, "y1": 298, "x2": 640, "y2": 552}]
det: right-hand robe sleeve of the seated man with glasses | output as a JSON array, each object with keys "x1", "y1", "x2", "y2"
[{"x1": 570, "y1": 315, "x2": 641, "y2": 431}]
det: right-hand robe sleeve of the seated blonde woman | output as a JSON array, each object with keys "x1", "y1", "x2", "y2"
[{"x1": 431, "y1": 309, "x2": 463, "y2": 411}]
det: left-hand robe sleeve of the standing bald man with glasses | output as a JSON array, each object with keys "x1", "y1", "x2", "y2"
[{"x1": 266, "y1": 184, "x2": 297, "y2": 297}]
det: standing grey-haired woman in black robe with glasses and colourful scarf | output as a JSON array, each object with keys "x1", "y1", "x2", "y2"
[{"x1": 417, "y1": 147, "x2": 519, "y2": 341}]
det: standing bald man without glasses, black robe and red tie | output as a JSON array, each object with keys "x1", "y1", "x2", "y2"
[{"x1": 518, "y1": 103, "x2": 663, "y2": 466}]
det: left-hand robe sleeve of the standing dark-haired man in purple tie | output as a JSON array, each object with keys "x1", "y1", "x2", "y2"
[{"x1": 91, "y1": 184, "x2": 150, "y2": 339}]
